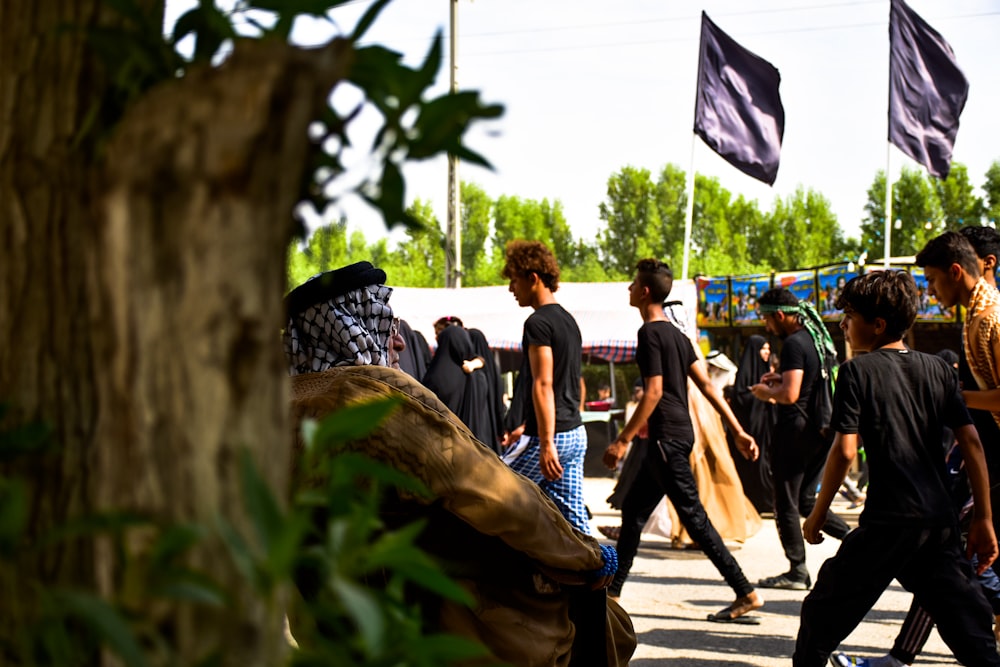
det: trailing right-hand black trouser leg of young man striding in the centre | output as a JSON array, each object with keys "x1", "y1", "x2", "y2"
[{"x1": 650, "y1": 441, "x2": 753, "y2": 598}]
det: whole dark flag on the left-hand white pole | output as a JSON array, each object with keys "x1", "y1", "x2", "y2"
[{"x1": 694, "y1": 12, "x2": 785, "y2": 185}]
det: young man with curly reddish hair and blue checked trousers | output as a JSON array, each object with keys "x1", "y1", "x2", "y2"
[{"x1": 503, "y1": 241, "x2": 590, "y2": 535}]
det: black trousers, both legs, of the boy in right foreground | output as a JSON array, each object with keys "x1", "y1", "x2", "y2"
[{"x1": 792, "y1": 524, "x2": 1000, "y2": 667}]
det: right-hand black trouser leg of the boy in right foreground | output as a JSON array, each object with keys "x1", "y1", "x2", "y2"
[{"x1": 898, "y1": 528, "x2": 1000, "y2": 667}]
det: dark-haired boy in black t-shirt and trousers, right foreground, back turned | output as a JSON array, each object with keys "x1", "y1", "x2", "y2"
[{"x1": 792, "y1": 271, "x2": 1000, "y2": 667}]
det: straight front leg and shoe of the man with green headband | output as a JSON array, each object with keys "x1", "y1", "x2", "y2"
[{"x1": 759, "y1": 425, "x2": 809, "y2": 586}]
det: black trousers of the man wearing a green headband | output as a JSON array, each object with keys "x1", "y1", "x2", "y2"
[{"x1": 771, "y1": 419, "x2": 851, "y2": 580}]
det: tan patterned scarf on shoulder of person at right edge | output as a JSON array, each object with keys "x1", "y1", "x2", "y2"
[{"x1": 962, "y1": 278, "x2": 1000, "y2": 424}]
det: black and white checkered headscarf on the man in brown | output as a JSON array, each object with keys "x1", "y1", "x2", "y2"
[{"x1": 283, "y1": 274, "x2": 393, "y2": 375}]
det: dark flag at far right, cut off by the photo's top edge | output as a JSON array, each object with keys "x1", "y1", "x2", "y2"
[{"x1": 889, "y1": 0, "x2": 969, "y2": 178}]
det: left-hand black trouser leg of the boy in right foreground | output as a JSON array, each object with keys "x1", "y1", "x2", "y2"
[{"x1": 792, "y1": 527, "x2": 907, "y2": 667}]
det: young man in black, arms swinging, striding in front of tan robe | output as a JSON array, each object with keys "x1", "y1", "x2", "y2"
[{"x1": 604, "y1": 259, "x2": 764, "y2": 622}]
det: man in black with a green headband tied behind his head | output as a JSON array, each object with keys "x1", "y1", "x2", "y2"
[{"x1": 750, "y1": 287, "x2": 850, "y2": 590}]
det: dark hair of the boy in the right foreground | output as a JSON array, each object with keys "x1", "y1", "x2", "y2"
[{"x1": 834, "y1": 269, "x2": 919, "y2": 340}]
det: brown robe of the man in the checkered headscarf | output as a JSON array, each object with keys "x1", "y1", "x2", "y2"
[{"x1": 292, "y1": 366, "x2": 636, "y2": 667}]
